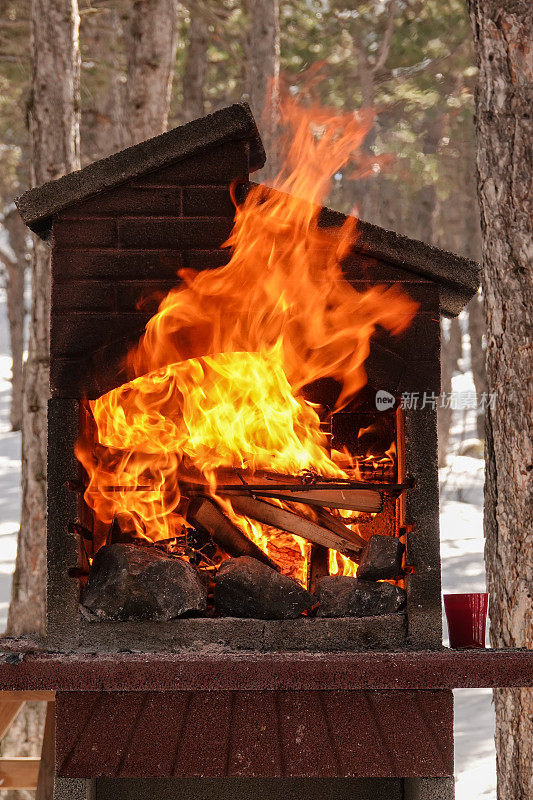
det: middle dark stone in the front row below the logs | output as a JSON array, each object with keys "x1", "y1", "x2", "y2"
[{"x1": 215, "y1": 556, "x2": 316, "y2": 619}]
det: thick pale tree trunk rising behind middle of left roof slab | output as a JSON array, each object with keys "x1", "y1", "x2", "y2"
[{"x1": 127, "y1": 0, "x2": 178, "y2": 144}]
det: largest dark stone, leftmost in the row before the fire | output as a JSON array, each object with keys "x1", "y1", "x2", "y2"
[{"x1": 81, "y1": 544, "x2": 207, "y2": 620}]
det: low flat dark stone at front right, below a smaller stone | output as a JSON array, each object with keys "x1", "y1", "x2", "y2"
[{"x1": 317, "y1": 575, "x2": 405, "y2": 617}]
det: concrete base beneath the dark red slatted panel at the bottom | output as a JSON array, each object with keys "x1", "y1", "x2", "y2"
[{"x1": 54, "y1": 778, "x2": 455, "y2": 800}]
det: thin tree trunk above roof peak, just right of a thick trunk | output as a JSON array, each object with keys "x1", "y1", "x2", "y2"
[{"x1": 183, "y1": 2, "x2": 209, "y2": 122}]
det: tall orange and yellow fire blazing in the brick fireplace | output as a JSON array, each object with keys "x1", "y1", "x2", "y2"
[{"x1": 77, "y1": 90, "x2": 416, "y2": 580}]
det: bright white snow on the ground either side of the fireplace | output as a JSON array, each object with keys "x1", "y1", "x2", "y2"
[{"x1": 0, "y1": 293, "x2": 496, "y2": 800}]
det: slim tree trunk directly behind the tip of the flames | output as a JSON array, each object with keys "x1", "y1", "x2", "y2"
[{"x1": 248, "y1": 0, "x2": 280, "y2": 180}]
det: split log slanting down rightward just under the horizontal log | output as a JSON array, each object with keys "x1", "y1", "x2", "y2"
[{"x1": 227, "y1": 495, "x2": 361, "y2": 558}]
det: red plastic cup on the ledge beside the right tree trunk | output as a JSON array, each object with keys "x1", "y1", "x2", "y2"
[{"x1": 444, "y1": 592, "x2": 489, "y2": 648}]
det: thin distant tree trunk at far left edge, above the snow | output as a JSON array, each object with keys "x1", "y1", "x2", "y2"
[{"x1": 0, "y1": 205, "x2": 27, "y2": 431}]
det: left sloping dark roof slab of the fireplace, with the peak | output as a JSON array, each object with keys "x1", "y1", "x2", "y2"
[{"x1": 16, "y1": 103, "x2": 266, "y2": 240}]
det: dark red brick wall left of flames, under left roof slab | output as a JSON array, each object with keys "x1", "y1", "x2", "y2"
[{"x1": 50, "y1": 142, "x2": 249, "y2": 398}]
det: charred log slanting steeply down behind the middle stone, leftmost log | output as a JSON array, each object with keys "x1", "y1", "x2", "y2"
[{"x1": 187, "y1": 497, "x2": 279, "y2": 570}]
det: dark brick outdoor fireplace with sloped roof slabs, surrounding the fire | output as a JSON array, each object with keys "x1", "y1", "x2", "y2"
[{"x1": 12, "y1": 105, "x2": 486, "y2": 800}]
